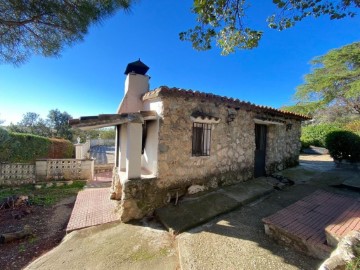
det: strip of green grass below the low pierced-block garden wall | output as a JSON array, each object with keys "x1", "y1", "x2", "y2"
[{"x1": 0, "y1": 181, "x2": 86, "y2": 206}]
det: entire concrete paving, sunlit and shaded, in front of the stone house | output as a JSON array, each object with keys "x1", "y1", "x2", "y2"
[{"x1": 27, "y1": 155, "x2": 360, "y2": 270}]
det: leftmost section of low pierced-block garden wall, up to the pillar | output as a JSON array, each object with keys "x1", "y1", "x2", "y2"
[{"x1": 0, "y1": 163, "x2": 35, "y2": 186}]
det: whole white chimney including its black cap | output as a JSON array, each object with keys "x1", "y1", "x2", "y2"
[{"x1": 118, "y1": 59, "x2": 150, "y2": 113}]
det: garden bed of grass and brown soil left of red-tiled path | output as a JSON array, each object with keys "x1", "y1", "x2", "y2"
[{"x1": 0, "y1": 184, "x2": 81, "y2": 270}]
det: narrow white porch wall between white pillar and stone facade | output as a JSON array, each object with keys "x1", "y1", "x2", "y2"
[{"x1": 141, "y1": 120, "x2": 159, "y2": 175}]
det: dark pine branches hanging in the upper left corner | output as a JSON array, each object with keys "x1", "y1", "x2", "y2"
[{"x1": 0, "y1": 0, "x2": 133, "y2": 64}]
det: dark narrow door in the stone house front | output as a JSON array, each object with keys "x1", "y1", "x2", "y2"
[{"x1": 254, "y1": 124, "x2": 267, "y2": 177}]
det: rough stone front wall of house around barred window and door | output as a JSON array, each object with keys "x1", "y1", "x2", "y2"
[{"x1": 158, "y1": 96, "x2": 301, "y2": 188}]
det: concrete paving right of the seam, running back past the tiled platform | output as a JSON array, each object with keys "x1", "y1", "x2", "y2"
[{"x1": 174, "y1": 161, "x2": 360, "y2": 269}]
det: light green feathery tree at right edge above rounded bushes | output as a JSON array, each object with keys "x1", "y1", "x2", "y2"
[{"x1": 284, "y1": 42, "x2": 360, "y2": 116}]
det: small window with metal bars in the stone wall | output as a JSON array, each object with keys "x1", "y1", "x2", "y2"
[{"x1": 192, "y1": 123, "x2": 211, "y2": 156}]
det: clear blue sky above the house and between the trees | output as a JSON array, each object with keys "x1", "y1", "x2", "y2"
[{"x1": 0, "y1": 0, "x2": 360, "y2": 124}]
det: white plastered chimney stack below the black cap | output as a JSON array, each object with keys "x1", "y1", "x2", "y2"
[{"x1": 118, "y1": 73, "x2": 150, "y2": 113}]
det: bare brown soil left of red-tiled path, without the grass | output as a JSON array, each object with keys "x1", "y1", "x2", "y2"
[{"x1": 0, "y1": 196, "x2": 75, "y2": 270}]
